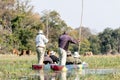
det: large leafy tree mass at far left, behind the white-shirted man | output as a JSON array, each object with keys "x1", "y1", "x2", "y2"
[{"x1": 0, "y1": 0, "x2": 43, "y2": 51}]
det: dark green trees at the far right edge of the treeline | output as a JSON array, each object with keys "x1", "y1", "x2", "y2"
[{"x1": 98, "y1": 28, "x2": 120, "y2": 54}]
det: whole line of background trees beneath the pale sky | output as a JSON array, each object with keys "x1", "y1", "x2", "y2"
[{"x1": 0, "y1": 0, "x2": 120, "y2": 54}]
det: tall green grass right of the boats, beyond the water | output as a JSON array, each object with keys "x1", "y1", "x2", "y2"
[{"x1": 82, "y1": 55, "x2": 120, "y2": 69}]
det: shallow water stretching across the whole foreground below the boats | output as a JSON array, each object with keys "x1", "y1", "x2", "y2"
[{"x1": 0, "y1": 66, "x2": 120, "y2": 80}]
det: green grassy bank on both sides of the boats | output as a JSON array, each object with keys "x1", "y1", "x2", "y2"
[{"x1": 0, "y1": 55, "x2": 120, "y2": 80}]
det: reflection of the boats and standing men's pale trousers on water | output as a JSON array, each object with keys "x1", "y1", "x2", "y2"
[{"x1": 29, "y1": 70, "x2": 80, "y2": 80}]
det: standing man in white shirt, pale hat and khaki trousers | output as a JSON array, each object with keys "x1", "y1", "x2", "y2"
[{"x1": 35, "y1": 30, "x2": 48, "y2": 65}]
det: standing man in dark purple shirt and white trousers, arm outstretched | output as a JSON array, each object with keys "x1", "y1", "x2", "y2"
[{"x1": 58, "y1": 31, "x2": 79, "y2": 66}]
